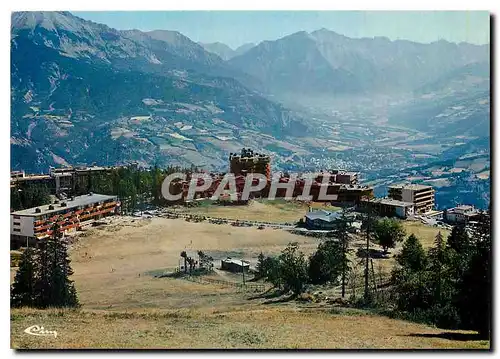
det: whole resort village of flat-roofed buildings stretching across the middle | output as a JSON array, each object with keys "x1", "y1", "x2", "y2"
[{"x1": 7, "y1": 149, "x2": 483, "y2": 249}]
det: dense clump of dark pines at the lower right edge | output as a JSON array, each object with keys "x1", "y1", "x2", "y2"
[{"x1": 393, "y1": 215, "x2": 491, "y2": 339}]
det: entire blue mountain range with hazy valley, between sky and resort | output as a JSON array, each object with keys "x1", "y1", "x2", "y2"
[{"x1": 11, "y1": 12, "x2": 490, "y2": 198}]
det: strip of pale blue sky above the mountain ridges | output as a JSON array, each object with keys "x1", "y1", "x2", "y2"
[{"x1": 73, "y1": 11, "x2": 490, "y2": 48}]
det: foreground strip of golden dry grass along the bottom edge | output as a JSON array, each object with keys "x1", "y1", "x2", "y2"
[{"x1": 11, "y1": 307, "x2": 489, "y2": 349}]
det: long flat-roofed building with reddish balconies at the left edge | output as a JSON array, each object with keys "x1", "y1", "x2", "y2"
[{"x1": 10, "y1": 193, "x2": 120, "y2": 245}]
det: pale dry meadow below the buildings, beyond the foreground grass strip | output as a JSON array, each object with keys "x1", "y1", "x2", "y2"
[{"x1": 57, "y1": 218, "x2": 317, "y2": 310}]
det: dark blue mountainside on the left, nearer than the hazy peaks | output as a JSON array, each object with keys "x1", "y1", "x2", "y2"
[{"x1": 11, "y1": 12, "x2": 307, "y2": 171}]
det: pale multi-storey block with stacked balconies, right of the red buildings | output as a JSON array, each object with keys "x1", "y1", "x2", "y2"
[{"x1": 388, "y1": 184, "x2": 434, "y2": 213}]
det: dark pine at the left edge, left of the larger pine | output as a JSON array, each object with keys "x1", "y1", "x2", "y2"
[{"x1": 10, "y1": 248, "x2": 37, "y2": 307}]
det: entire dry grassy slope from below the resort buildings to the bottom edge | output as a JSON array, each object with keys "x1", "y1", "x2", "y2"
[{"x1": 11, "y1": 212, "x2": 488, "y2": 348}]
